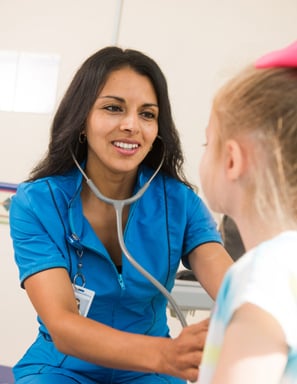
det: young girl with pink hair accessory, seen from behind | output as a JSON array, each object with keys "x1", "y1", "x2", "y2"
[{"x1": 199, "y1": 42, "x2": 297, "y2": 384}]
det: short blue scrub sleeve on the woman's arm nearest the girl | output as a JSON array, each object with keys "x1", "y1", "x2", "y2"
[{"x1": 182, "y1": 190, "x2": 222, "y2": 269}]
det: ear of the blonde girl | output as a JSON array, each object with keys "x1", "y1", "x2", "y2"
[{"x1": 225, "y1": 139, "x2": 244, "y2": 181}]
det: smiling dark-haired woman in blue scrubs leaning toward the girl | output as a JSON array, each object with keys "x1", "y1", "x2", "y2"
[{"x1": 10, "y1": 47, "x2": 232, "y2": 384}]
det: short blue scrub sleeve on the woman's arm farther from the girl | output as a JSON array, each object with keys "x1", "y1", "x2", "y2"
[{"x1": 9, "y1": 186, "x2": 67, "y2": 286}]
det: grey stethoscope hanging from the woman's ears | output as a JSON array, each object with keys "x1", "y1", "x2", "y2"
[{"x1": 71, "y1": 143, "x2": 187, "y2": 327}]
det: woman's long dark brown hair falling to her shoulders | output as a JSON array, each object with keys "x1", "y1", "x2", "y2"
[{"x1": 29, "y1": 47, "x2": 191, "y2": 187}]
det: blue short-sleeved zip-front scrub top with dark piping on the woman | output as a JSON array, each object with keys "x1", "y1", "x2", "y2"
[{"x1": 10, "y1": 166, "x2": 221, "y2": 378}]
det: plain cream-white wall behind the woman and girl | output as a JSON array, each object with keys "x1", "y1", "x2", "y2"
[{"x1": 0, "y1": 0, "x2": 297, "y2": 364}]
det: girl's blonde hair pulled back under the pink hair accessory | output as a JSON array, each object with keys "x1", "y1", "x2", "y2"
[{"x1": 213, "y1": 66, "x2": 297, "y2": 227}]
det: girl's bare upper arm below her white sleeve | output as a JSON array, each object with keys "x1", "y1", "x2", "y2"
[{"x1": 210, "y1": 303, "x2": 288, "y2": 384}]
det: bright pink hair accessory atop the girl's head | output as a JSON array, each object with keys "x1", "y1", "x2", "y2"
[{"x1": 255, "y1": 41, "x2": 297, "y2": 68}]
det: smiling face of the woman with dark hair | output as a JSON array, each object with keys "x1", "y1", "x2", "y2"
[{"x1": 85, "y1": 67, "x2": 159, "y2": 177}]
